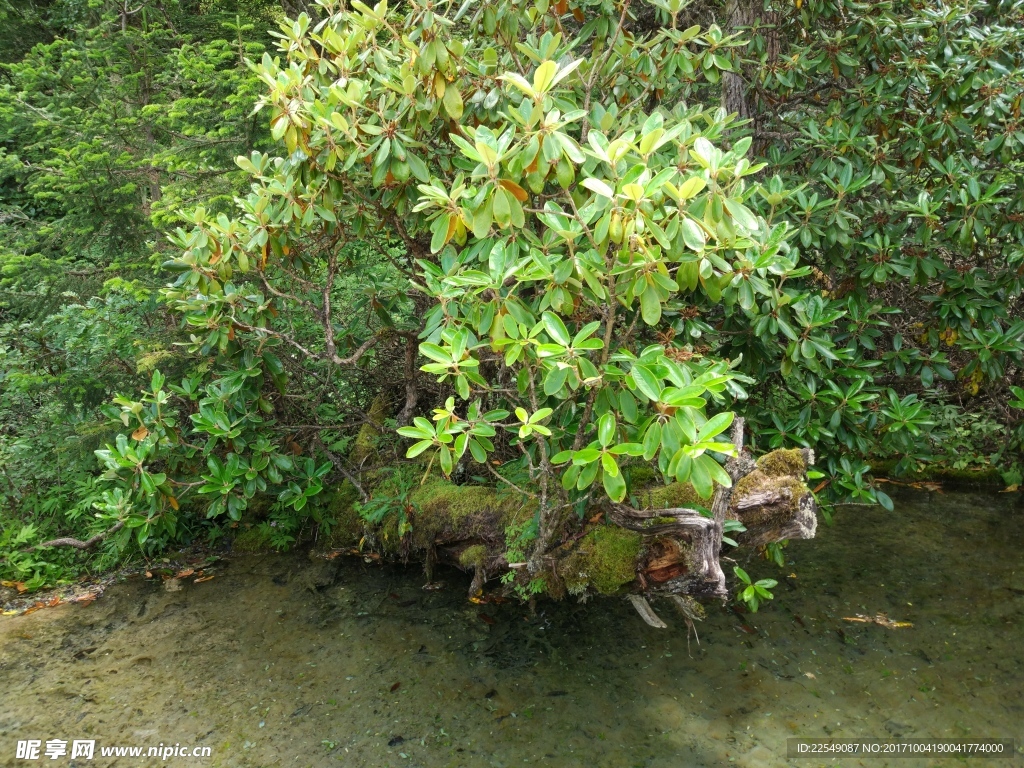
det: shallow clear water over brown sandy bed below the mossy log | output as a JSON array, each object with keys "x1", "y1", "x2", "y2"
[{"x1": 0, "y1": 493, "x2": 1024, "y2": 768}]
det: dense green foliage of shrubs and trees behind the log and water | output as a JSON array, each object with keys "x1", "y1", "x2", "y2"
[{"x1": 0, "y1": 0, "x2": 1024, "y2": 584}]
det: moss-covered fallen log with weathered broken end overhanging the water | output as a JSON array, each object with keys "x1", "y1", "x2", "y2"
[{"x1": 333, "y1": 419, "x2": 816, "y2": 626}]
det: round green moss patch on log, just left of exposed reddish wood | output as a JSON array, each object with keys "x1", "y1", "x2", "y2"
[{"x1": 558, "y1": 525, "x2": 643, "y2": 595}]
